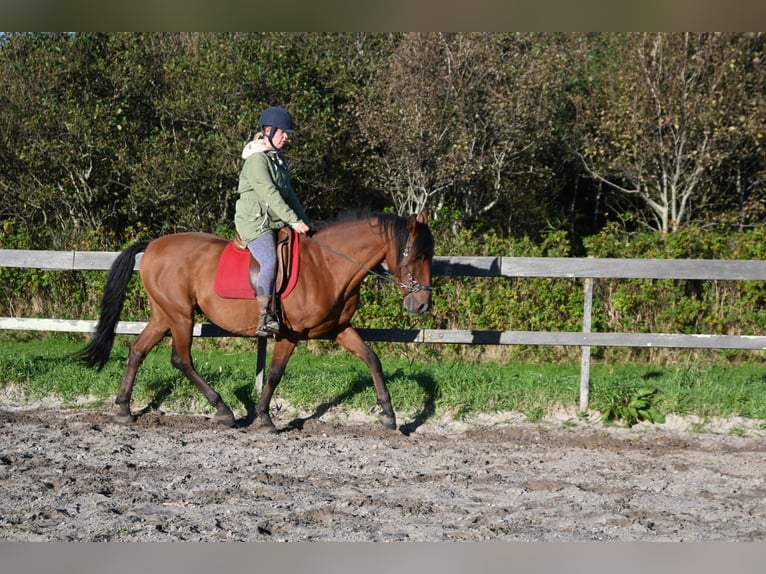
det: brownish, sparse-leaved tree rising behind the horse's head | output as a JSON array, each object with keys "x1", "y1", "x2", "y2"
[{"x1": 355, "y1": 33, "x2": 561, "y2": 236}]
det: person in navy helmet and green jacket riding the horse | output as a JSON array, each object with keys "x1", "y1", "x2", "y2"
[{"x1": 234, "y1": 106, "x2": 310, "y2": 337}]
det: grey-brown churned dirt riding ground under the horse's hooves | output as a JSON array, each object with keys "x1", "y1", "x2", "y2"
[{"x1": 0, "y1": 405, "x2": 766, "y2": 541}]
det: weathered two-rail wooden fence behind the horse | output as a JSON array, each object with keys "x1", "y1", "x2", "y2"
[{"x1": 0, "y1": 249, "x2": 766, "y2": 411}]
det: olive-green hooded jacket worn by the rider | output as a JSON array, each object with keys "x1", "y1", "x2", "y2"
[{"x1": 234, "y1": 140, "x2": 309, "y2": 248}]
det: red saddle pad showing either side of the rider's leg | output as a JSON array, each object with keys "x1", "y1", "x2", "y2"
[{"x1": 213, "y1": 227, "x2": 300, "y2": 299}]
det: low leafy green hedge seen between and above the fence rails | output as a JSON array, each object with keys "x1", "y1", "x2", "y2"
[{"x1": 0, "y1": 220, "x2": 766, "y2": 360}]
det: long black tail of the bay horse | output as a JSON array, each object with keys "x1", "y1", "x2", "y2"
[{"x1": 73, "y1": 241, "x2": 149, "y2": 371}]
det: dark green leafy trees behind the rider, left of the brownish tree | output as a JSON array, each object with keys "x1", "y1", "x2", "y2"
[{"x1": 0, "y1": 33, "x2": 376, "y2": 247}]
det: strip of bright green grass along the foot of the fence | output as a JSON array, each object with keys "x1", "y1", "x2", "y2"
[{"x1": 0, "y1": 333, "x2": 766, "y2": 428}]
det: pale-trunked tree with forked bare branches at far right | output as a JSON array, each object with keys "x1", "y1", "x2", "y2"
[{"x1": 573, "y1": 33, "x2": 763, "y2": 232}]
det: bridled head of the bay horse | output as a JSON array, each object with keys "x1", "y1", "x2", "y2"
[{"x1": 388, "y1": 210, "x2": 434, "y2": 315}]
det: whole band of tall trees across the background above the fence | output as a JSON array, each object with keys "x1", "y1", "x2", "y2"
[{"x1": 0, "y1": 32, "x2": 766, "y2": 249}]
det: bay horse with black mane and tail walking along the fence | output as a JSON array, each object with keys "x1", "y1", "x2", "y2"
[{"x1": 76, "y1": 211, "x2": 434, "y2": 432}]
